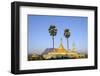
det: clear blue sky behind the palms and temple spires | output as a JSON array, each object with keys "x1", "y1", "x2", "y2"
[{"x1": 28, "y1": 15, "x2": 88, "y2": 54}]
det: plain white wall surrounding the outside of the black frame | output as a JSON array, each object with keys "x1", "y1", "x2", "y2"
[{"x1": 0, "y1": 0, "x2": 100, "y2": 76}]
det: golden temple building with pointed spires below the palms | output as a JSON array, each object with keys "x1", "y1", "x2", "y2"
[{"x1": 42, "y1": 39, "x2": 78, "y2": 59}]
